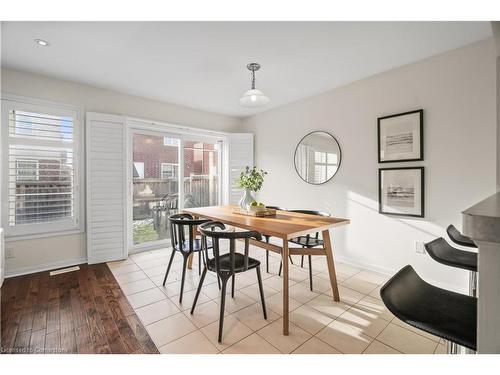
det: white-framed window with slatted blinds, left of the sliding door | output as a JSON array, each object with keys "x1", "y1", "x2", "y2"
[{"x1": 2, "y1": 100, "x2": 81, "y2": 235}]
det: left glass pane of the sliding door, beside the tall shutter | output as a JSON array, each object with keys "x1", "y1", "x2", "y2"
[{"x1": 132, "y1": 133, "x2": 180, "y2": 245}]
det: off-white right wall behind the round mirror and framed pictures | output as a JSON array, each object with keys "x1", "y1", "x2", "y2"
[{"x1": 243, "y1": 40, "x2": 496, "y2": 290}]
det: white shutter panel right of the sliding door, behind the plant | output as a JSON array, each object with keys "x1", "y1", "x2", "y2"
[{"x1": 228, "y1": 133, "x2": 253, "y2": 204}]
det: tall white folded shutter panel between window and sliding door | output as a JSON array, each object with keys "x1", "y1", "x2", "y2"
[{"x1": 86, "y1": 113, "x2": 127, "y2": 264}]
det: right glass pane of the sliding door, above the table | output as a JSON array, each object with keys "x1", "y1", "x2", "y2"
[{"x1": 184, "y1": 141, "x2": 221, "y2": 208}]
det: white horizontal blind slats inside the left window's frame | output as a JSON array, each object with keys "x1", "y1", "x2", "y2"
[{"x1": 7, "y1": 110, "x2": 75, "y2": 226}]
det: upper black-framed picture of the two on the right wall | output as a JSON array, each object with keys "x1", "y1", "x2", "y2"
[{"x1": 377, "y1": 109, "x2": 424, "y2": 163}]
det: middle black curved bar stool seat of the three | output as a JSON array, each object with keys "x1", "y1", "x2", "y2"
[{"x1": 425, "y1": 237, "x2": 477, "y2": 272}]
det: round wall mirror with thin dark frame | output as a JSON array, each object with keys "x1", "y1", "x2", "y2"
[{"x1": 294, "y1": 131, "x2": 342, "y2": 185}]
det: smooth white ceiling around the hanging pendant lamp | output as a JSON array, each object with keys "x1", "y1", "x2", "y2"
[{"x1": 2, "y1": 22, "x2": 492, "y2": 117}]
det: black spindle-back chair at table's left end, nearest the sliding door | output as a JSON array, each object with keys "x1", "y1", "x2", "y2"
[{"x1": 163, "y1": 214, "x2": 211, "y2": 303}]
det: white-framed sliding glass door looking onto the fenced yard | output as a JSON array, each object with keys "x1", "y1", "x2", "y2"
[{"x1": 129, "y1": 128, "x2": 222, "y2": 252}]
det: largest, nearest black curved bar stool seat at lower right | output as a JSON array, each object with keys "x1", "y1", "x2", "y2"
[{"x1": 380, "y1": 265, "x2": 477, "y2": 350}]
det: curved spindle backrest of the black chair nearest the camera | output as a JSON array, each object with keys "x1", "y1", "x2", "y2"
[{"x1": 199, "y1": 221, "x2": 262, "y2": 275}]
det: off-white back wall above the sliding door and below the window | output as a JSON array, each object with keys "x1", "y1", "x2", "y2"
[{"x1": 1, "y1": 69, "x2": 241, "y2": 275}]
